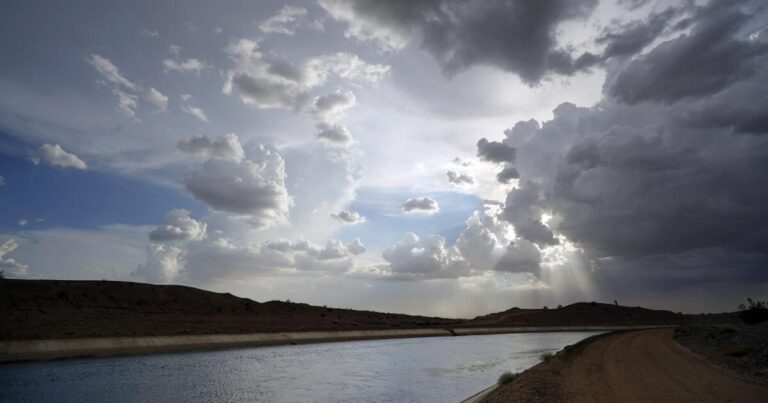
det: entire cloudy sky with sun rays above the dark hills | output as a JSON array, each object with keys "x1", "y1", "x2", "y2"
[{"x1": 0, "y1": 0, "x2": 768, "y2": 317}]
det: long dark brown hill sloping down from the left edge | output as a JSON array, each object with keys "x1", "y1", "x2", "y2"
[{"x1": 0, "y1": 279, "x2": 463, "y2": 340}]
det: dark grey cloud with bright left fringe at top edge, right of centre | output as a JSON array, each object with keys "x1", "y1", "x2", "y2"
[{"x1": 319, "y1": 0, "x2": 598, "y2": 84}]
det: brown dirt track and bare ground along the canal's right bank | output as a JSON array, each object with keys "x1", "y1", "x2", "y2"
[{"x1": 484, "y1": 329, "x2": 768, "y2": 402}]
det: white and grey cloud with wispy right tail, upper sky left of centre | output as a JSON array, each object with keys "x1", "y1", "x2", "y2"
[{"x1": 223, "y1": 39, "x2": 389, "y2": 110}]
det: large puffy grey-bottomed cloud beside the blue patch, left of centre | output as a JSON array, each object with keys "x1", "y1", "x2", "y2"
[{"x1": 184, "y1": 140, "x2": 292, "y2": 227}]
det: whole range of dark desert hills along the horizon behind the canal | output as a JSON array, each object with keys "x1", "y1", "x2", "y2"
[{"x1": 0, "y1": 279, "x2": 735, "y2": 340}]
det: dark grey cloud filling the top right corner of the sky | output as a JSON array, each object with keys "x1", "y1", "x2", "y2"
[{"x1": 606, "y1": 1, "x2": 768, "y2": 104}]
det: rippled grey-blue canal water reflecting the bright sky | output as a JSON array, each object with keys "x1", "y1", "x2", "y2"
[{"x1": 0, "y1": 332, "x2": 599, "y2": 403}]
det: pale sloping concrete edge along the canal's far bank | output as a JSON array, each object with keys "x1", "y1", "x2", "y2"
[{"x1": 0, "y1": 326, "x2": 672, "y2": 363}]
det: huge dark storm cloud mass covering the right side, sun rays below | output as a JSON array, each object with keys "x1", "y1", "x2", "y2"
[{"x1": 478, "y1": 2, "x2": 768, "y2": 295}]
